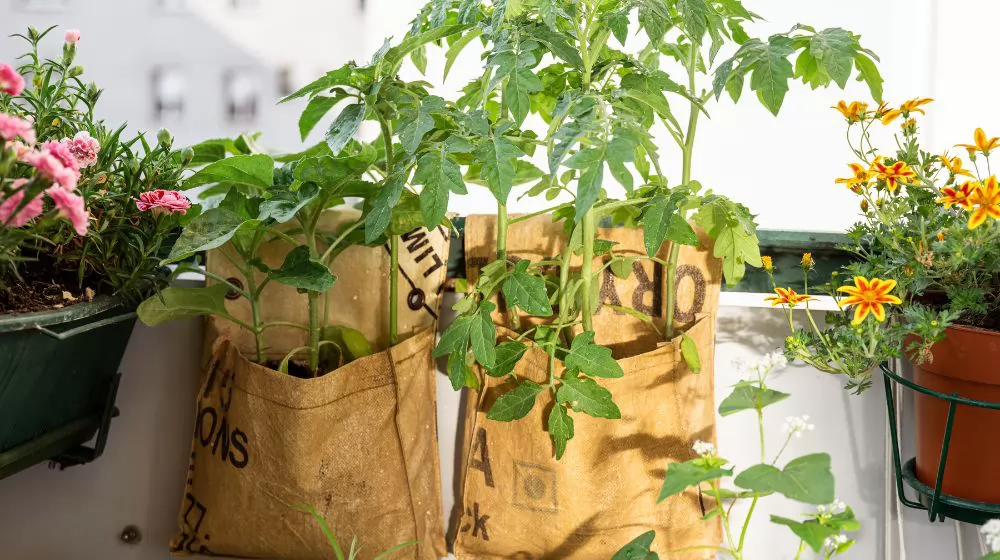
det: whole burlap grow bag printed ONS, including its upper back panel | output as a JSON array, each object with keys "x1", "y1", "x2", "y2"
[{"x1": 171, "y1": 212, "x2": 449, "y2": 560}]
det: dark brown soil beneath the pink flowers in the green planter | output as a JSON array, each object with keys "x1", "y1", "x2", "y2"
[{"x1": 0, "y1": 261, "x2": 98, "y2": 315}]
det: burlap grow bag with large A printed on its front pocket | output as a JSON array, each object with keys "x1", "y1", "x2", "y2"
[{"x1": 452, "y1": 212, "x2": 722, "y2": 560}]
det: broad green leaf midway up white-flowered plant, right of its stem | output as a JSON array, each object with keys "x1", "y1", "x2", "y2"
[{"x1": 734, "y1": 453, "x2": 834, "y2": 505}]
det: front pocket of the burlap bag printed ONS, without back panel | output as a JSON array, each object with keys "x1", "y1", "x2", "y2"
[{"x1": 171, "y1": 330, "x2": 444, "y2": 560}]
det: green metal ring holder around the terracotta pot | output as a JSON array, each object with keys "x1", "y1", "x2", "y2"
[{"x1": 880, "y1": 363, "x2": 1000, "y2": 525}]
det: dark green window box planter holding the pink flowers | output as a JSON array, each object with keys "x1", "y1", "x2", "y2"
[{"x1": 0, "y1": 297, "x2": 135, "y2": 478}]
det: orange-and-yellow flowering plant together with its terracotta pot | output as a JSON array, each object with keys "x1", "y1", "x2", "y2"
[{"x1": 769, "y1": 99, "x2": 1000, "y2": 504}]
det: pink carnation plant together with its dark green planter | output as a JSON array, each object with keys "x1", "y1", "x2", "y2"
[{"x1": 0, "y1": 28, "x2": 190, "y2": 474}]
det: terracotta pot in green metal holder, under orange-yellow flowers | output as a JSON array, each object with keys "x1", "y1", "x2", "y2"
[{"x1": 914, "y1": 326, "x2": 1000, "y2": 504}]
